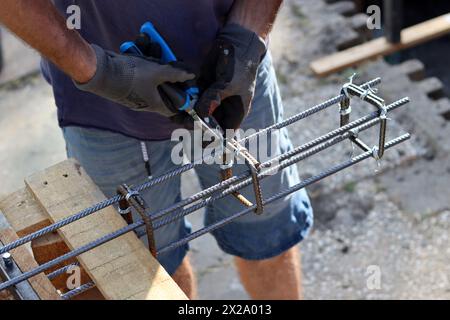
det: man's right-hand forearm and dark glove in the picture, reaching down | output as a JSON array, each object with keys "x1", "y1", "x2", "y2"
[{"x1": 196, "y1": 0, "x2": 282, "y2": 129}]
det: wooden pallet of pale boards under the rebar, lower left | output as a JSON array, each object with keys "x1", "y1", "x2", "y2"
[{"x1": 0, "y1": 160, "x2": 187, "y2": 300}]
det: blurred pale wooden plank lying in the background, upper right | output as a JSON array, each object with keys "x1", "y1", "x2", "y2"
[{"x1": 310, "y1": 14, "x2": 450, "y2": 77}]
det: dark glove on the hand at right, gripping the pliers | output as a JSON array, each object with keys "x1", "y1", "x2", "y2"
[{"x1": 195, "y1": 24, "x2": 267, "y2": 130}]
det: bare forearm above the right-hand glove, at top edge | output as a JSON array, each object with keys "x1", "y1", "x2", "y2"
[{"x1": 228, "y1": 0, "x2": 283, "y2": 39}]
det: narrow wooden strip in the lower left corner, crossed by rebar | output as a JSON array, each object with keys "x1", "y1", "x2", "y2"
[{"x1": 0, "y1": 213, "x2": 61, "y2": 300}]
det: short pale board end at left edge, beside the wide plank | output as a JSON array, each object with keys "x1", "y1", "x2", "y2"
[{"x1": 0, "y1": 188, "x2": 50, "y2": 237}]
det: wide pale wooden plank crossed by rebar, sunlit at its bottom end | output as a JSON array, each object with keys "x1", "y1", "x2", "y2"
[{"x1": 25, "y1": 160, "x2": 187, "y2": 300}]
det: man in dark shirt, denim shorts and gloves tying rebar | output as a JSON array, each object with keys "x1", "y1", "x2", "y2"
[{"x1": 0, "y1": 0, "x2": 312, "y2": 299}]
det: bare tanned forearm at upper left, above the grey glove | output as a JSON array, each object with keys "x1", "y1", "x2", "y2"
[{"x1": 0, "y1": 0, "x2": 96, "y2": 82}]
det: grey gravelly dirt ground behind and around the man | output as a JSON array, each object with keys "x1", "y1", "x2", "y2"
[{"x1": 0, "y1": 0, "x2": 450, "y2": 299}]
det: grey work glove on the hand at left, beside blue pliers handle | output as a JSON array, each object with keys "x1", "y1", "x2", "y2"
[{"x1": 75, "y1": 45, "x2": 195, "y2": 117}]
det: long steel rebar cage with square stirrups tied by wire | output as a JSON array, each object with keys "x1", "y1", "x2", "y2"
[{"x1": 0, "y1": 78, "x2": 410, "y2": 298}]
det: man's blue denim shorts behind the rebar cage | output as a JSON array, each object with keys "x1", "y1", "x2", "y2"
[{"x1": 63, "y1": 54, "x2": 313, "y2": 274}]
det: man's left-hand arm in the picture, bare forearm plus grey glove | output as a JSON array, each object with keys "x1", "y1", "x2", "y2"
[{"x1": 0, "y1": 0, "x2": 195, "y2": 117}]
